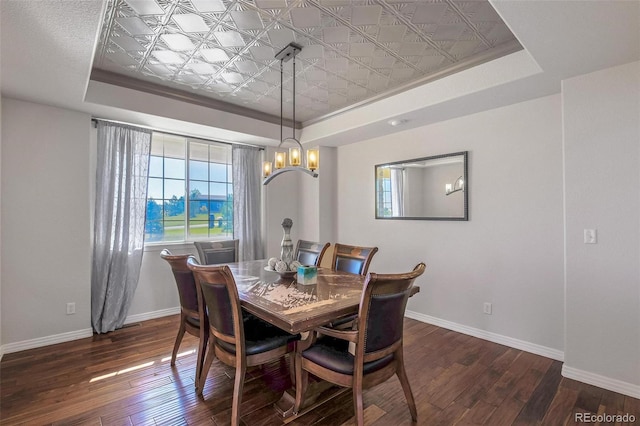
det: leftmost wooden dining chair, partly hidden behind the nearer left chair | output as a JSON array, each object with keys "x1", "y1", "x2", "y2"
[{"x1": 160, "y1": 249, "x2": 209, "y2": 388}]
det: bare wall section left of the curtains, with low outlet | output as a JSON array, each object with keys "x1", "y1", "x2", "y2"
[{"x1": 1, "y1": 98, "x2": 94, "y2": 344}]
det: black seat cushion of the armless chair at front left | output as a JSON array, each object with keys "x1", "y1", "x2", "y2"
[{"x1": 217, "y1": 314, "x2": 300, "y2": 356}]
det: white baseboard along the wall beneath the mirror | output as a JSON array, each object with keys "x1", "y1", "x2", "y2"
[{"x1": 405, "y1": 311, "x2": 564, "y2": 361}]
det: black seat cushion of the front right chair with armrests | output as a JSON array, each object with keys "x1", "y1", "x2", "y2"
[{"x1": 302, "y1": 336, "x2": 393, "y2": 375}]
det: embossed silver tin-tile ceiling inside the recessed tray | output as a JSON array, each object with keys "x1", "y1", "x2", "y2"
[{"x1": 92, "y1": 0, "x2": 521, "y2": 122}]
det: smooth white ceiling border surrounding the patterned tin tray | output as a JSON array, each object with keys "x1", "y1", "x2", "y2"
[{"x1": 0, "y1": 0, "x2": 640, "y2": 146}]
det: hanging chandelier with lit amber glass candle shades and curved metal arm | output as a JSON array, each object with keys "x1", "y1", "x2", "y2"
[{"x1": 262, "y1": 43, "x2": 320, "y2": 185}]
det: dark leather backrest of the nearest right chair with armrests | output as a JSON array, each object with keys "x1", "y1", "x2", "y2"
[{"x1": 358, "y1": 263, "x2": 426, "y2": 355}]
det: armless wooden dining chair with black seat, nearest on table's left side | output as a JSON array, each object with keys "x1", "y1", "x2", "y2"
[{"x1": 187, "y1": 256, "x2": 300, "y2": 425}]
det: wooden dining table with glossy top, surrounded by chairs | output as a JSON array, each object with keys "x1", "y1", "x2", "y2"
[{"x1": 228, "y1": 259, "x2": 420, "y2": 423}]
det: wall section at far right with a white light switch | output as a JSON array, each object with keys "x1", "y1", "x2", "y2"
[{"x1": 562, "y1": 62, "x2": 640, "y2": 390}]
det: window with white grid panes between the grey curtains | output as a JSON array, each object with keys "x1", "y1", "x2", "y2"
[{"x1": 145, "y1": 132, "x2": 233, "y2": 242}]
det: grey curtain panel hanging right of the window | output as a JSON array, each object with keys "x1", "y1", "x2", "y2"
[{"x1": 232, "y1": 145, "x2": 264, "y2": 261}]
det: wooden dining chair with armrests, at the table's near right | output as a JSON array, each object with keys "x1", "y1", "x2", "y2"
[{"x1": 294, "y1": 263, "x2": 426, "y2": 426}]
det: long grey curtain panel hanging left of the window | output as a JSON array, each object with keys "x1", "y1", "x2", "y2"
[{"x1": 91, "y1": 121, "x2": 151, "y2": 333}]
